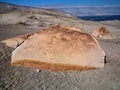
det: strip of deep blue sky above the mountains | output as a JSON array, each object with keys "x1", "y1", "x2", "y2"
[{"x1": 0, "y1": 0, "x2": 120, "y2": 7}]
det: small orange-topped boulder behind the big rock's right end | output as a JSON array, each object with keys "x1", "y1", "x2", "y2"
[{"x1": 92, "y1": 27, "x2": 113, "y2": 39}]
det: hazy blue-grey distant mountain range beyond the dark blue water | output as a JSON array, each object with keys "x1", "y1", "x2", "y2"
[{"x1": 39, "y1": 5, "x2": 120, "y2": 16}]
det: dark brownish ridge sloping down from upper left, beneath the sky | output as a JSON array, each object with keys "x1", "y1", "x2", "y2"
[{"x1": 0, "y1": 2, "x2": 77, "y2": 18}]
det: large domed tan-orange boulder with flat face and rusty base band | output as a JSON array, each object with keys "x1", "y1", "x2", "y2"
[{"x1": 11, "y1": 27, "x2": 105, "y2": 71}]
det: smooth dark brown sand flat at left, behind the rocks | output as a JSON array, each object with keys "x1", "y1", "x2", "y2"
[{"x1": 0, "y1": 24, "x2": 41, "y2": 41}]
